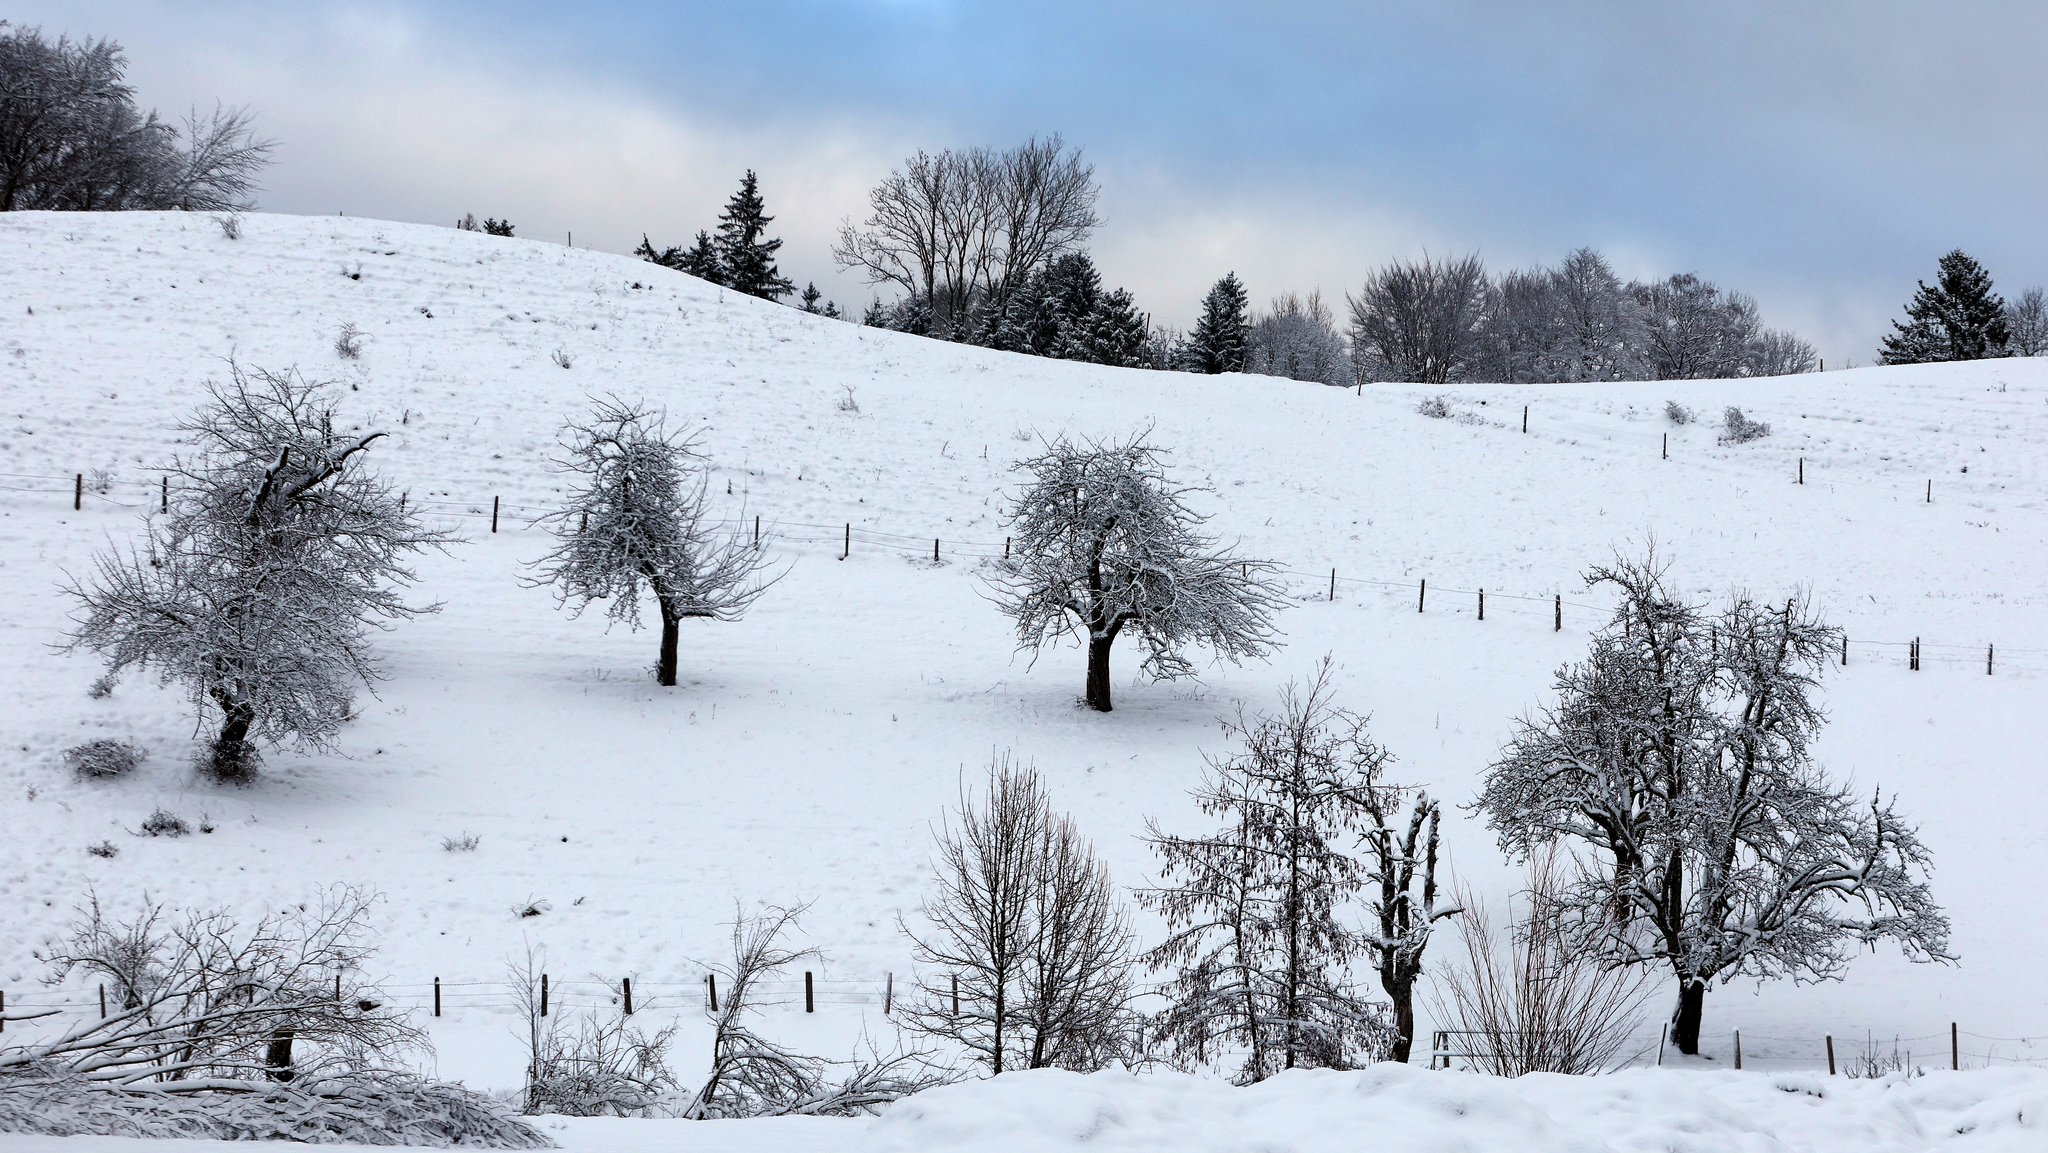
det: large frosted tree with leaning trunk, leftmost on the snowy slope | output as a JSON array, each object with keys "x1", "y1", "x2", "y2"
[{"x1": 68, "y1": 362, "x2": 449, "y2": 780}]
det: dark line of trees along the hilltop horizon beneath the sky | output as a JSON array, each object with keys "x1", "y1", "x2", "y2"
[{"x1": 0, "y1": 20, "x2": 2048, "y2": 385}]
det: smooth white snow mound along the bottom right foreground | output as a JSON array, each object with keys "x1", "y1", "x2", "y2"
[{"x1": 864, "y1": 1065, "x2": 2048, "y2": 1153}]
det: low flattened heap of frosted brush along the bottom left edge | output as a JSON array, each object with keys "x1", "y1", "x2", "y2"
[{"x1": 0, "y1": 1069, "x2": 553, "y2": 1149}]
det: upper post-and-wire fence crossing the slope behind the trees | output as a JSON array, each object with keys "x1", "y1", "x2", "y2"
[{"x1": 0, "y1": 464, "x2": 2048, "y2": 676}]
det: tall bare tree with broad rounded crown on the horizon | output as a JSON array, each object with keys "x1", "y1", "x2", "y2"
[{"x1": 834, "y1": 135, "x2": 1096, "y2": 334}]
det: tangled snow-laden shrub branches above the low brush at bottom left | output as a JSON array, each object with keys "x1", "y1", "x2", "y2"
[{"x1": 0, "y1": 887, "x2": 424, "y2": 1094}]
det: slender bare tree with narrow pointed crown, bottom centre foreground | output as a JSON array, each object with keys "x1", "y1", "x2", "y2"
[{"x1": 903, "y1": 756, "x2": 1141, "y2": 1073}]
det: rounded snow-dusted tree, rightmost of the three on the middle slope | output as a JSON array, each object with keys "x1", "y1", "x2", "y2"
[{"x1": 991, "y1": 434, "x2": 1286, "y2": 713}]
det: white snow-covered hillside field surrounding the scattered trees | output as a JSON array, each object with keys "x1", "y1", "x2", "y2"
[{"x1": 0, "y1": 213, "x2": 2048, "y2": 1149}]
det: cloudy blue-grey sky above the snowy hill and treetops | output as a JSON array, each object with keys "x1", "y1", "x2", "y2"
[{"x1": 8, "y1": 0, "x2": 2048, "y2": 365}]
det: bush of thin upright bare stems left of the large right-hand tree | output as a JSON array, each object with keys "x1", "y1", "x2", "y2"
[{"x1": 1434, "y1": 850, "x2": 1649, "y2": 1077}]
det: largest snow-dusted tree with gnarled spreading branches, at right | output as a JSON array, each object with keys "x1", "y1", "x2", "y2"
[{"x1": 1479, "y1": 553, "x2": 1950, "y2": 1053}]
